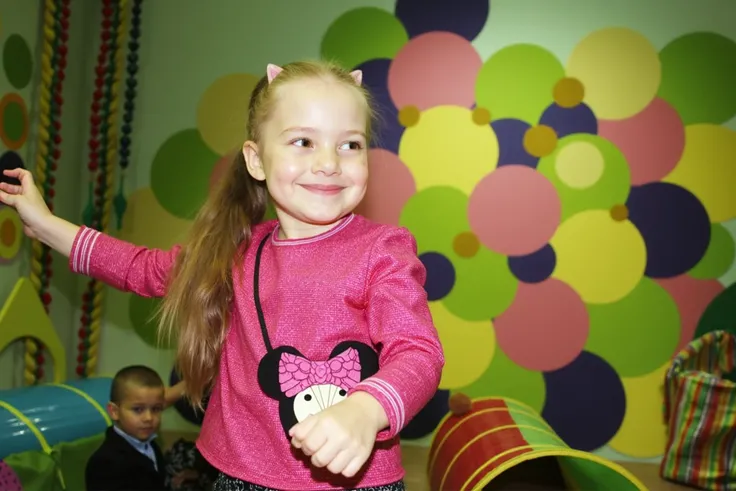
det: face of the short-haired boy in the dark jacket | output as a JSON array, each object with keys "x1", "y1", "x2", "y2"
[{"x1": 107, "y1": 384, "x2": 165, "y2": 441}]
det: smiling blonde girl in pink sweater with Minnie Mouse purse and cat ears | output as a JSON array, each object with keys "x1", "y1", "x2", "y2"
[{"x1": 0, "y1": 62, "x2": 444, "y2": 491}]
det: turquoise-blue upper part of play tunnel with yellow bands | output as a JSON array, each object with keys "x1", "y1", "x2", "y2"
[{"x1": 0, "y1": 377, "x2": 112, "y2": 460}]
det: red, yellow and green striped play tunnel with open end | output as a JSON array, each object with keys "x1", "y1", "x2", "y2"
[{"x1": 427, "y1": 398, "x2": 647, "y2": 491}]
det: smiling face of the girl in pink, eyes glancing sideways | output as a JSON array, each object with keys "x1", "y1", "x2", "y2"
[{"x1": 243, "y1": 78, "x2": 368, "y2": 238}]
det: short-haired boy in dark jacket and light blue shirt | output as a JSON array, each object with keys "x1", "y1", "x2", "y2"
[{"x1": 85, "y1": 365, "x2": 196, "y2": 491}]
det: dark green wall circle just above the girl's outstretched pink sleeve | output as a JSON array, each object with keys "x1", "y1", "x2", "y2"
[{"x1": 151, "y1": 129, "x2": 220, "y2": 220}]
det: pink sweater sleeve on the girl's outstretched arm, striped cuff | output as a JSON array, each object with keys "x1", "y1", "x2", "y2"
[{"x1": 69, "y1": 227, "x2": 181, "y2": 297}]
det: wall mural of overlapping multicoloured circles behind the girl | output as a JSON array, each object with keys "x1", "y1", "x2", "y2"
[{"x1": 80, "y1": 0, "x2": 736, "y2": 458}]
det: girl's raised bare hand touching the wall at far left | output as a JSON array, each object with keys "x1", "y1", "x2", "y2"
[{"x1": 0, "y1": 168, "x2": 53, "y2": 239}]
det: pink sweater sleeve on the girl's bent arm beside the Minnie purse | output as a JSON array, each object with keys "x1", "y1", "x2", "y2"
[{"x1": 353, "y1": 228, "x2": 445, "y2": 441}]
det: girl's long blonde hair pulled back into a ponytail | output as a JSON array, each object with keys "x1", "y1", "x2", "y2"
[{"x1": 159, "y1": 61, "x2": 375, "y2": 408}]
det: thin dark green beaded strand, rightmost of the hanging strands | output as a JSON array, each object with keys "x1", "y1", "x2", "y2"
[{"x1": 114, "y1": 0, "x2": 143, "y2": 230}]
